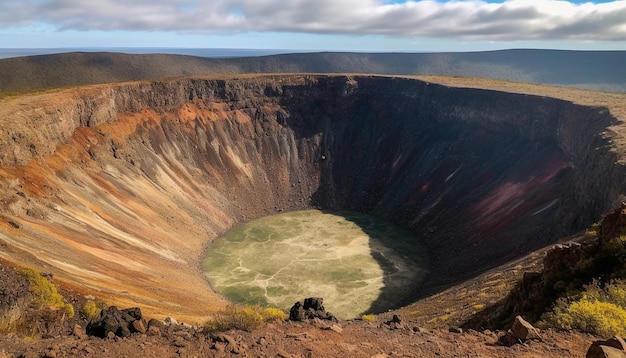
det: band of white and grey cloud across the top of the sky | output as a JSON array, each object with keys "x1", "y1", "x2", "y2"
[{"x1": 0, "y1": 0, "x2": 626, "y2": 41}]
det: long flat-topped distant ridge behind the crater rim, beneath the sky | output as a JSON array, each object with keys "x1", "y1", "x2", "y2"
[{"x1": 0, "y1": 49, "x2": 626, "y2": 92}]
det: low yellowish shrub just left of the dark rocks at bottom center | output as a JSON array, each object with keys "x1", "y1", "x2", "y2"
[{"x1": 204, "y1": 305, "x2": 287, "y2": 332}]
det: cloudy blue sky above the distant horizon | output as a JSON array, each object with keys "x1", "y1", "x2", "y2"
[{"x1": 0, "y1": 0, "x2": 626, "y2": 52}]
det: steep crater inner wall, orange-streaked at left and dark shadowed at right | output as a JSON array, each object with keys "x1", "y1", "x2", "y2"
[{"x1": 0, "y1": 75, "x2": 624, "y2": 316}]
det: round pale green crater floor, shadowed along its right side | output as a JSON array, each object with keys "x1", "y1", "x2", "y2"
[{"x1": 203, "y1": 210, "x2": 426, "y2": 319}]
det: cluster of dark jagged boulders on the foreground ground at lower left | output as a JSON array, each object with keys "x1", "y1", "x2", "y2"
[{"x1": 87, "y1": 306, "x2": 146, "y2": 338}]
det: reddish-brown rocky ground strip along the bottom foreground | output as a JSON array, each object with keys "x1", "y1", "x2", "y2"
[{"x1": 0, "y1": 314, "x2": 595, "y2": 358}]
